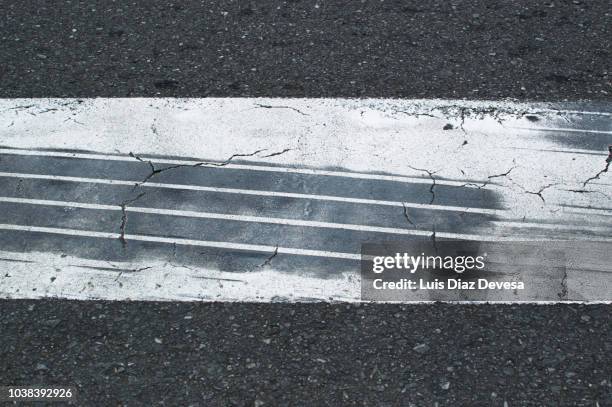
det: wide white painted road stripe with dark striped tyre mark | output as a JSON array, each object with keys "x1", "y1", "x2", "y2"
[{"x1": 0, "y1": 98, "x2": 612, "y2": 302}]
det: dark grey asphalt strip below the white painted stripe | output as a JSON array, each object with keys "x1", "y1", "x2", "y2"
[{"x1": 0, "y1": 301, "x2": 612, "y2": 407}]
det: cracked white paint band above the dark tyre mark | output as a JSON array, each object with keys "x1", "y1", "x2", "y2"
[{"x1": 0, "y1": 98, "x2": 612, "y2": 212}]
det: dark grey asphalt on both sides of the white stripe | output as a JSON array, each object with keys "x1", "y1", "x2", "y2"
[{"x1": 0, "y1": 0, "x2": 612, "y2": 407}]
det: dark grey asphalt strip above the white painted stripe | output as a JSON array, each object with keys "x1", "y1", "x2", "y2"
[{"x1": 0, "y1": 0, "x2": 612, "y2": 100}]
